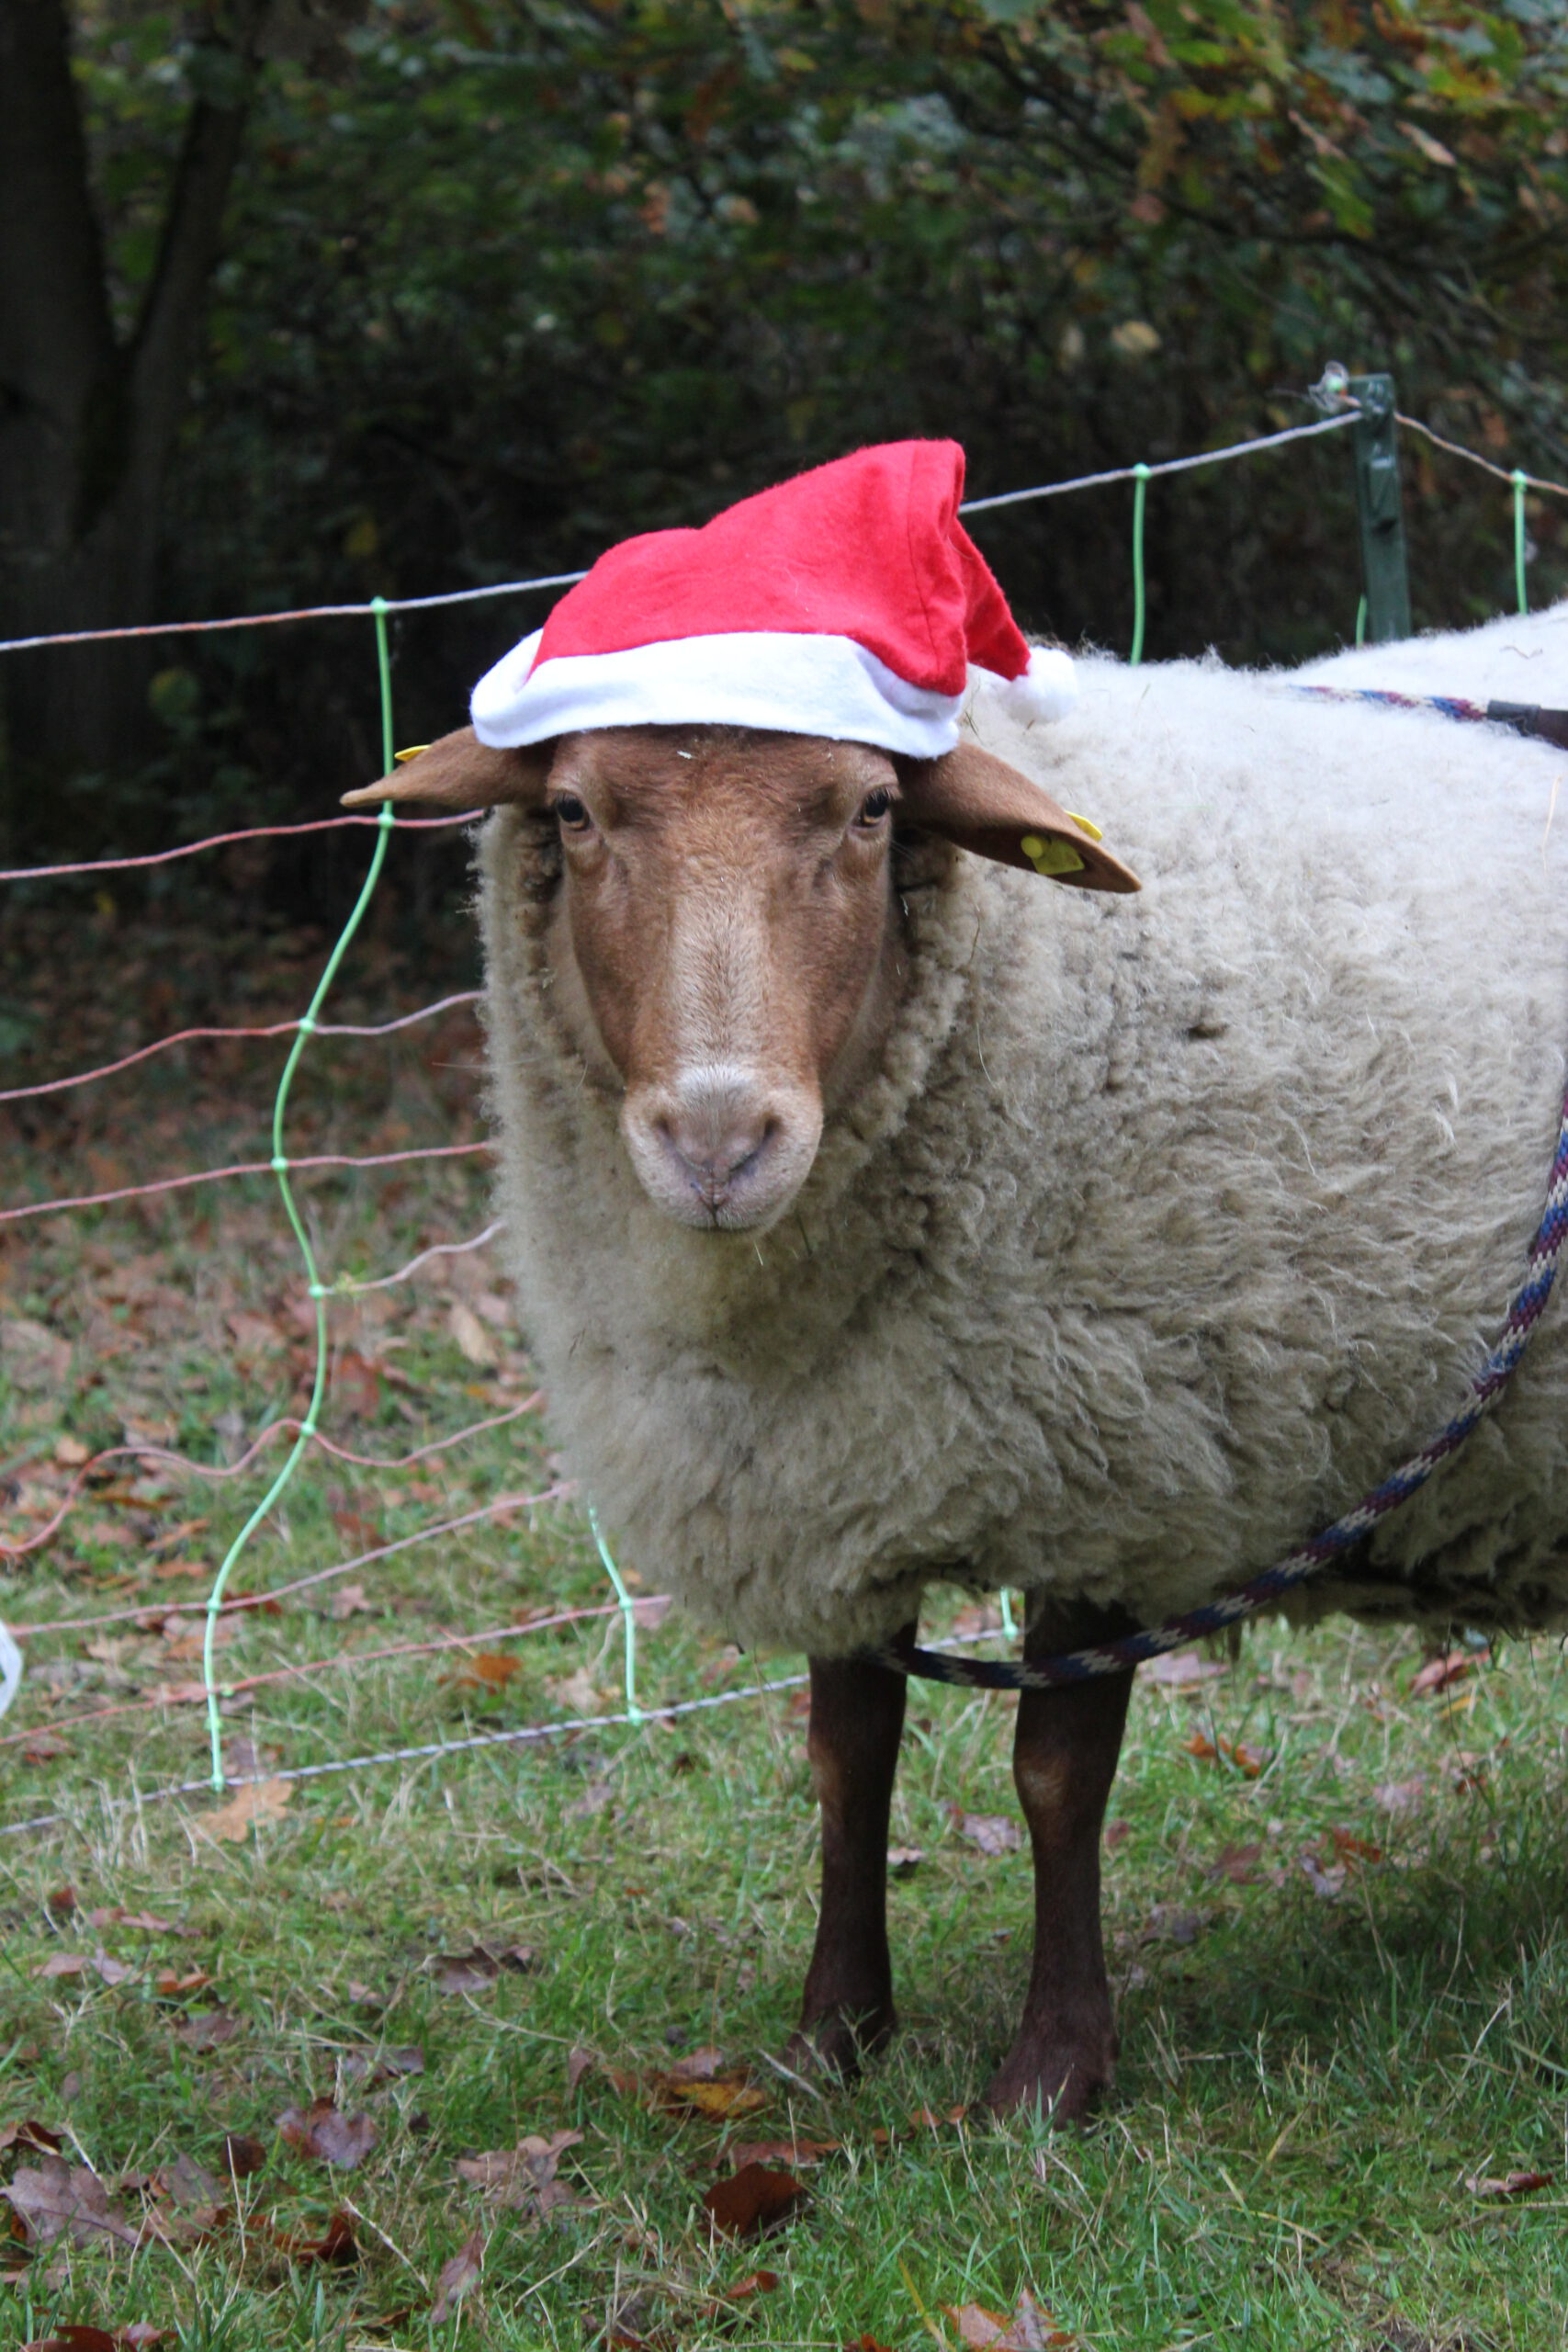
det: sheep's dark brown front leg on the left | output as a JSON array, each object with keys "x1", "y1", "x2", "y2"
[{"x1": 785, "y1": 1628, "x2": 915, "y2": 2075}]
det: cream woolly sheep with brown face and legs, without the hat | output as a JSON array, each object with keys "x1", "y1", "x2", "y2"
[{"x1": 355, "y1": 606, "x2": 1568, "y2": 2120}]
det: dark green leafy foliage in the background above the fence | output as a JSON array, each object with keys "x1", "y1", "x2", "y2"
[{"x1": 39, "y1": 0, "x2": 1568, "y2": 837}]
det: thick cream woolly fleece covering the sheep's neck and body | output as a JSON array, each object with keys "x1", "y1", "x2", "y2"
[{"x1": 479, "y1": 616, "x2": 1568, "y2": 1656}]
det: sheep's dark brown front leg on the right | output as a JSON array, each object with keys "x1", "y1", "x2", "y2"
[{"x1": 985, "y1": 1613, "x2": 1134, "y2": 2124}]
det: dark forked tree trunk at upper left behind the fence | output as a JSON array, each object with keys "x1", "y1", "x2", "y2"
[{"x1": 0, "y1": 0, "x2": 254, "y2": 776}]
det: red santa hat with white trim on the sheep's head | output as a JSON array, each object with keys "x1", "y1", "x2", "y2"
[{"x1": 472, "y1": 440, "x2": 1077, "y2": 760}]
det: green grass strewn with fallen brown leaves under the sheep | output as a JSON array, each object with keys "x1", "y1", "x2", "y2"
[{"x1": 0, "y1": 903, "x2": 1568, "y2": 2352}]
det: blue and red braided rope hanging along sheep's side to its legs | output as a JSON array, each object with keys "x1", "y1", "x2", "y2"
[{"x1": 861, "y1": 1077, "x2": 1568, "y2": 1691}]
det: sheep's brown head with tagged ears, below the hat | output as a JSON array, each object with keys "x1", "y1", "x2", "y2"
[{"x1": 348, "y1": 727, "x2": 1138, "y2": 1230}]
